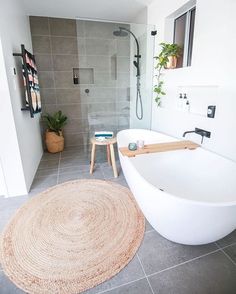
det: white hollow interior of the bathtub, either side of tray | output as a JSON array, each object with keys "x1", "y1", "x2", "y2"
[{"x1": 118, "y1": 130, "x2": 236, "y2": 203}]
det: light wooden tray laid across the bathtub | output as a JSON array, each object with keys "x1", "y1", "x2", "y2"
[{"x1": 119, "y1": 141, "x2": 200, "y2": 157}]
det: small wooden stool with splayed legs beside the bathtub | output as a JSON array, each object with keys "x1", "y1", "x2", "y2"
[{"x1": 90, "y1": 138, "x2": 118, "y2": 178}]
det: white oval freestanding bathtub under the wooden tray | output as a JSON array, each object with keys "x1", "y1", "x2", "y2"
[{"x1": 117, "y1": 129, "x2": 236, "y2": 245}]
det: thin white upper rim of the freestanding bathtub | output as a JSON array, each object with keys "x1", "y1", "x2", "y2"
[{"x1": 117, "y1": 129, "x2": 236, "y2": 207}]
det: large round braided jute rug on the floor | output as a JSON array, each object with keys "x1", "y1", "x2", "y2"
[{"x1": 0, "y1": 180, "x2": 145, "y2": 294}]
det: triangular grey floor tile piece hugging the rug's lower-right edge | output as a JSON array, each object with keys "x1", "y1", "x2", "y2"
[{"x1": 85, "y1": 256, "x2": 144, "y2": 294}]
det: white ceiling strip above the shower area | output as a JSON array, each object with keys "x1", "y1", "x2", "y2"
[{"x1": 22, "y1": 0, "x2": 153, "y2": 22}]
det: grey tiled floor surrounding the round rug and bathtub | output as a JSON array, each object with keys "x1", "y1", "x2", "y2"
[{"x1": 0, "y1": 147, "x2": 236, "y2": 294}]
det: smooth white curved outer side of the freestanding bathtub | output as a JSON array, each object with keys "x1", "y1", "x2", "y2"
[{"x1": 118, "y1": 129, "x2": 236, "y2": 245}]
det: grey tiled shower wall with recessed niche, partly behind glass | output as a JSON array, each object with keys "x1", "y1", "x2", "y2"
[{"x1": 30, "y1": 16, "x2": 130, "y2": 146}]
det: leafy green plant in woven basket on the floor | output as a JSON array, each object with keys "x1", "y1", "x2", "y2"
[{"x1": 44, "y1": 110, "x2": 67, "y2": 153}]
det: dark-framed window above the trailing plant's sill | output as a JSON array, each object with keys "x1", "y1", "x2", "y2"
[{"x1": 173, "y1": 7, "x2": 196, "y2": 67}]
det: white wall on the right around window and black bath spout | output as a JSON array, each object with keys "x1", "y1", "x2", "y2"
[{"x1": 148, "y1": 0, "x2": 236, "y2": 160}]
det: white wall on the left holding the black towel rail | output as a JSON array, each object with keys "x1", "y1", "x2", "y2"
[{"x1": 0, "y1": 0, "x2": 42, "y2": 196}]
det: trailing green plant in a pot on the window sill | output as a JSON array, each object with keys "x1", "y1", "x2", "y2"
[{"x1": 154, "y1": 43, "x2": 181, "y2": 106}]
